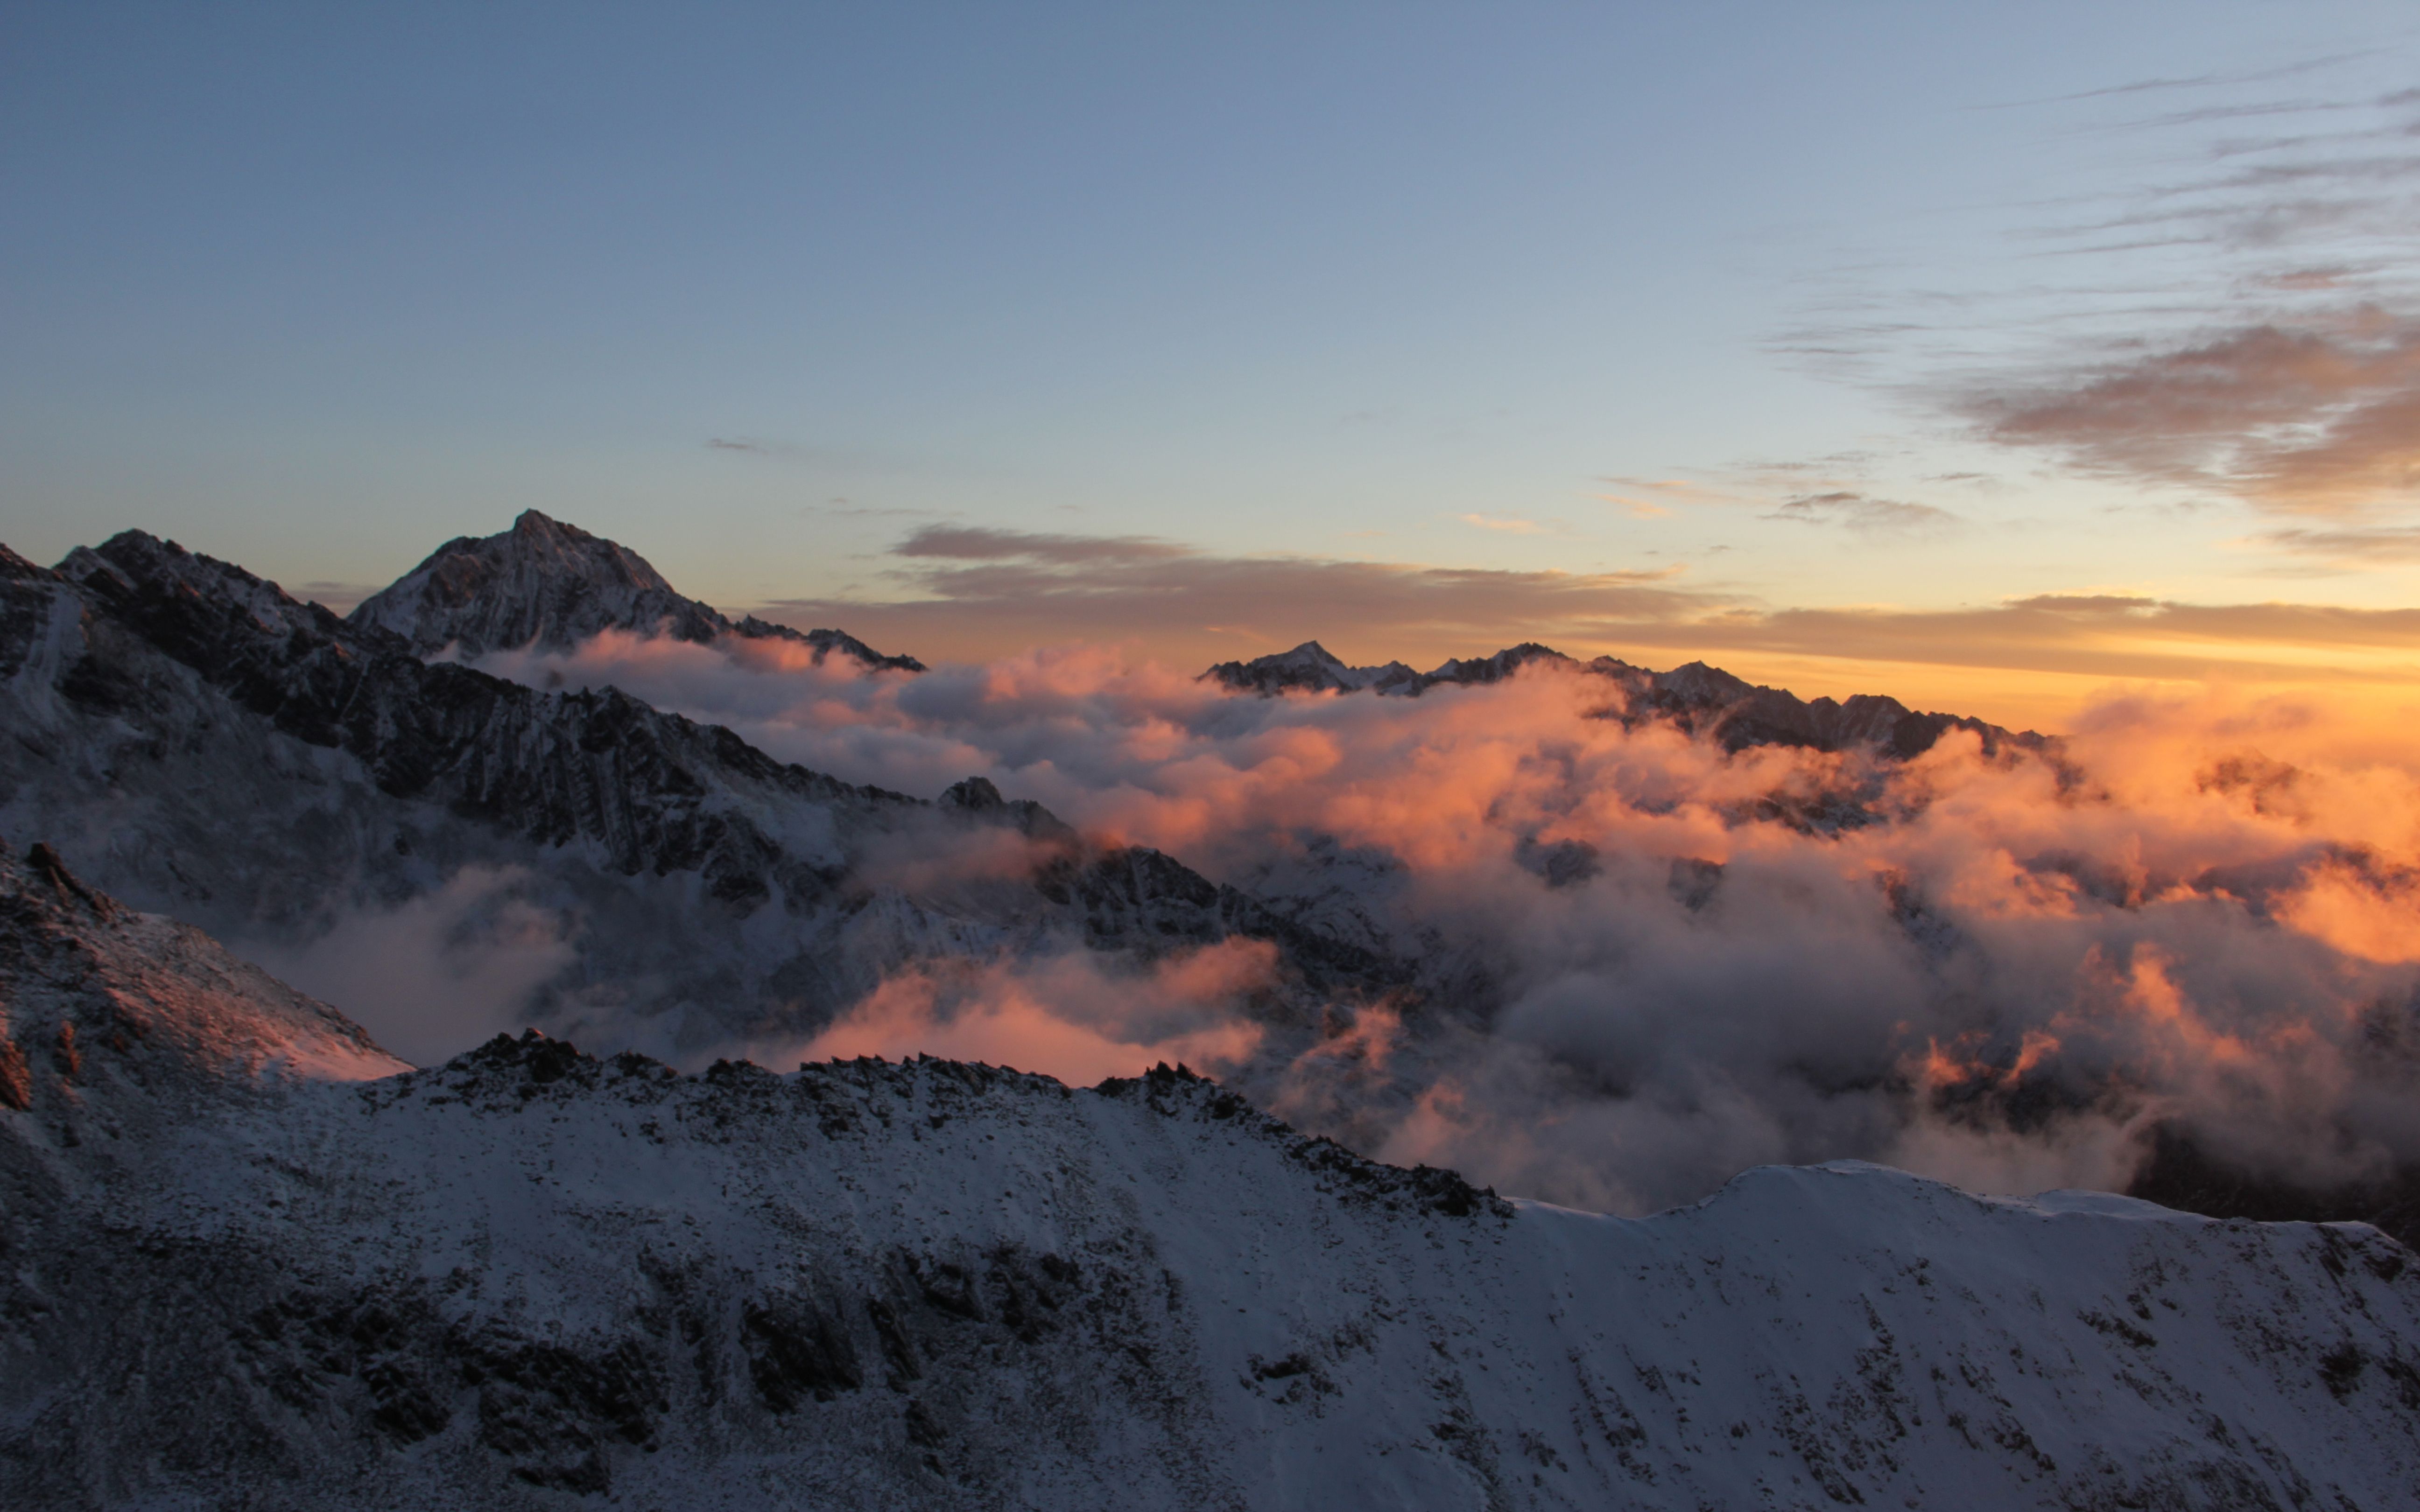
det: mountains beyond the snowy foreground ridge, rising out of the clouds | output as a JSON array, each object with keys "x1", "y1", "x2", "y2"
[{"x1": 0, "y1": 511, "x2": 2420, "y2": 1239}]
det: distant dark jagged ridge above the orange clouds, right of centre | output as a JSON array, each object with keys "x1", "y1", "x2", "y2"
[{"x1": 1200, "y1": 641, "x2": 2052, "y2": 760}]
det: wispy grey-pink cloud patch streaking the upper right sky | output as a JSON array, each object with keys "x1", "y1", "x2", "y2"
[{"x1": 1772, "y1": 43, "x2": 2420, "y2": 537}]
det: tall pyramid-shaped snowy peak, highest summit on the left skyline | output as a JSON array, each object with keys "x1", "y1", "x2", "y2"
[{"x1": 351, "y1": 511, "x2": 924, "y2": 672}]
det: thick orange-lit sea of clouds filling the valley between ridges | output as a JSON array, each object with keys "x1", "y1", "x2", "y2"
[{"x1": 457, "y1": 634, "x2": 2420, "y2": 1212}]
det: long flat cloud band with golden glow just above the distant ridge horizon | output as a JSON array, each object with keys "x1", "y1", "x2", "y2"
[{"x1": 740, "y1": 532, "x2": 2420, "y2": 682}]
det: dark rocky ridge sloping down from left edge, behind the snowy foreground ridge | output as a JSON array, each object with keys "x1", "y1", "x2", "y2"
[{"x1": 0, "y1": 520, "x2": 1404, "y2": 1057}]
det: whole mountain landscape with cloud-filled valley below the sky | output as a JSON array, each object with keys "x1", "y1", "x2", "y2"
[{"x1": 0, "y1": 513, "x2": 2420, "y2": 1510}]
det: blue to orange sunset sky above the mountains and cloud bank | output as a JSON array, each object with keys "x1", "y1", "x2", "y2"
[{"x1": 0, "y1": 0, "x2": 2420, "y2": 731}]
